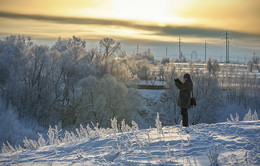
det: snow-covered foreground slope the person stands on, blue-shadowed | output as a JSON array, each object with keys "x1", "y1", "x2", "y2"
[{"x1": 0, "y1": 121, "x2": 260, "y2": 166}]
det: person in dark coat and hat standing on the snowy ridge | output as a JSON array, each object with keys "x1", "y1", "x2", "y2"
[{"x1": 174, "y1": 73, "x2": 193, "y2": 127}]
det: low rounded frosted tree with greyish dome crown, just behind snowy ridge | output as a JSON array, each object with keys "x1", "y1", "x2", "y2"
[{"x1": 75, "y1": 75, "x2": 140, "y2": 127}]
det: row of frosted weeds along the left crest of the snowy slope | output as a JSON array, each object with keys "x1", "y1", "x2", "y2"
[{"x1": 1, "y1": 118, "x2": 138, "y2": 153}]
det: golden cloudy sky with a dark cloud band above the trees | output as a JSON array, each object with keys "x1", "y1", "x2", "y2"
[{"x1": 0, "y1": 0, "x2": 260, "y2": 61}]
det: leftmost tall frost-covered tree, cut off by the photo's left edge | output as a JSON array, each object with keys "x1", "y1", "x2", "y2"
[{"x1": 0, "y1": 35, "x2": 38, "y2": 116}]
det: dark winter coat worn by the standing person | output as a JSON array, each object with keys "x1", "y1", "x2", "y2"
[{"x1": 175, "y1": 79, "x2": 193, "y2": 108}]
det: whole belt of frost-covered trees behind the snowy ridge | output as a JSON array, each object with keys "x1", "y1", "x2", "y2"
[{"x1": 0, "y1": 35, "x2": 260, "y2": 145}]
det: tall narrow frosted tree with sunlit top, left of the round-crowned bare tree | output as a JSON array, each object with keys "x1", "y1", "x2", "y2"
[{"x1": 52, "y1": 36, "x2": 89, "y2": 105}]
